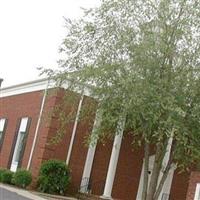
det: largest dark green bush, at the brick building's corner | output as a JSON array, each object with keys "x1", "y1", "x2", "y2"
[{"x1": 38, "y1": 160, "x2": 70, "y2": 194}]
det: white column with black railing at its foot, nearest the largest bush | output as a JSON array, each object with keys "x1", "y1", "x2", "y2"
[{"x1": 80, "y1": 111, "x2": 101, "y2": 192}]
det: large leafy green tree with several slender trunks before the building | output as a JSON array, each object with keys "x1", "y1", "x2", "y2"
[{"x1": 44, "y1": 0, "x2": 200, "y2": 200}]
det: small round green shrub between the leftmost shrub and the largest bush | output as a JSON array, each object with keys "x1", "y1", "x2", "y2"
[{"x1": 12, "y1": 169, "x2": 32, "y2": 188}]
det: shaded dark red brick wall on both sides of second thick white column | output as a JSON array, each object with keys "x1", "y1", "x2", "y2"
[{"x1": 91, "y1": 135, "x2": 143, "y2": 200}]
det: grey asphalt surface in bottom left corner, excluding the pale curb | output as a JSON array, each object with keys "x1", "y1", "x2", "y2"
[{"x1": 0, "y1": 187, "x2": 31, "y2": 200}]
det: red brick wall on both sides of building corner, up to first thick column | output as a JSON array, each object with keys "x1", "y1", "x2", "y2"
[{"x1": 0, "y1": 89, "x2": 97, "y2": 191}]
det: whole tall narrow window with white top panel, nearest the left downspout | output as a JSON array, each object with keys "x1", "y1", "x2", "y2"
[{"x1": 10, "y1": 117, "x2": 30, "y2": 172}]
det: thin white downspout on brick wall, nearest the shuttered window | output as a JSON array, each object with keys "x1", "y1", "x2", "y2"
[{"x1": 27, "y1": 82, "x2": 49, "y2": 170}]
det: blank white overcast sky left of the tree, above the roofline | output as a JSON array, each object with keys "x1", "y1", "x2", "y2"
[{"x1": 0, "y1": 0, "x2": 100, "y2": 87}]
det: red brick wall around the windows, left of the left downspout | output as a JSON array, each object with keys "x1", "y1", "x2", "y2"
[{"x1": 0, "y1": 91, "x2": 43, "y2": 168}]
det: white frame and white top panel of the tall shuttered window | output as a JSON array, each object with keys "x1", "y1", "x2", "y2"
[{"x1": 10, "y1": 117, "x2": 28, "y2": 172}]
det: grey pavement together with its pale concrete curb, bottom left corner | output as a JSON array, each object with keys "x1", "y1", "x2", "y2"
[{"x1": 0, "y1": 184, "x2": 46, "y2": 200}]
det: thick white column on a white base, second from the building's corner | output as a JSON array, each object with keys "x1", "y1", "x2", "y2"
[{"x1": 102, "y1": 117, "x2": 126, "y2": 199}]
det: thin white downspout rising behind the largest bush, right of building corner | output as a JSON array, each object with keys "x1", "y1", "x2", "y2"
[{"x1": 66, "y1": 95, "x2": 84, "y2": 165}]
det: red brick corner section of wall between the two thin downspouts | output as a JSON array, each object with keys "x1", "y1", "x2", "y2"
[{"x1": 28, "y1": 89, "x2": 77, "y2": 180}]
